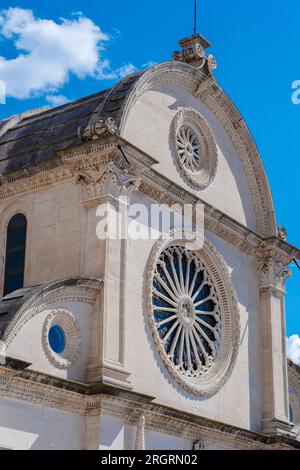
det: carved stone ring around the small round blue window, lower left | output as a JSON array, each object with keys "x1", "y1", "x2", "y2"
[{"x1": 42, "y1": 309, "x2": 81, "y2": 369}]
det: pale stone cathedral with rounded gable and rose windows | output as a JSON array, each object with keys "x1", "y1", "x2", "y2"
[{"x1": 0, "y1": 35, "x2": 300, "y2": 451}]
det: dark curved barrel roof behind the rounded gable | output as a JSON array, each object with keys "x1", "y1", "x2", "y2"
[{"x1": 0, "y1": 72, "x2": 144, "y2": 174}]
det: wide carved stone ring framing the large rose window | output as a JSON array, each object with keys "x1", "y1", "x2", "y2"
[{"x1": 144, "y1": 233, "x2": 240, "y2": 397}]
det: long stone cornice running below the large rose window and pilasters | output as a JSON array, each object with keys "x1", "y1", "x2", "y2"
[{"x1": 0, "y1": 366, "x2": 300, "y2": 449}]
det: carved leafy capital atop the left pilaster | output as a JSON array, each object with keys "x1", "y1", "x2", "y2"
[{"x1": 75, "y1": 162, "x2": 141, "y2": 199}]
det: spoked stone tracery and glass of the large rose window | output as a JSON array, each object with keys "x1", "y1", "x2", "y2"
[{"x1": 152, "y1": 246, "x2": 221, "y2": 377}]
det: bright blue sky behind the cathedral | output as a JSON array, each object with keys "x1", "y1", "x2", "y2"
[{"x1": 0, "y1": 0, "x2": 300, "y2": 342}]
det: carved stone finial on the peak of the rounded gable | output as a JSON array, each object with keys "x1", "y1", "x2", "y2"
[{"x1": 173, "y1": 34, "x2": 217, "y2": 75}]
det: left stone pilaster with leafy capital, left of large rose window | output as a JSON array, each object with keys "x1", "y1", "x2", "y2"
[{"x1": 75, "y1": 158, "x2": 140, "y2": 389}]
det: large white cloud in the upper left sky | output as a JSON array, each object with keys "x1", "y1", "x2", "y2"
[{"x1": 0, "y1": 8, "x2": 136, "y2": 103}]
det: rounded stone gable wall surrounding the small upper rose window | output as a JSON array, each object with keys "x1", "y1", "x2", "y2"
[{"x1": 118, "y1": 62, "x2": 277, "y2": 237}]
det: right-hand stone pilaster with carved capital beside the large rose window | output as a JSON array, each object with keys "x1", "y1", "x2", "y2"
[{"x1": 258, "y1": 249, "x2": 293, "y2": 436}]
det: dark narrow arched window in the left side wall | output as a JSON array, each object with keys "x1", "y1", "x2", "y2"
[{"x1": 3, "y1": 214, "x2": 27, "y2": 296}]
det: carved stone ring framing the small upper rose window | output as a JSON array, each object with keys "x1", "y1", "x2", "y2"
[{"x1": 170, "y1": 108, "x2": 218, "y2": 190}]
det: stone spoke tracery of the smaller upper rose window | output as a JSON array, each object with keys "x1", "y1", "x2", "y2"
[{"x1": 177, "y1": 126, "x2": 202, "y2": 173}]
